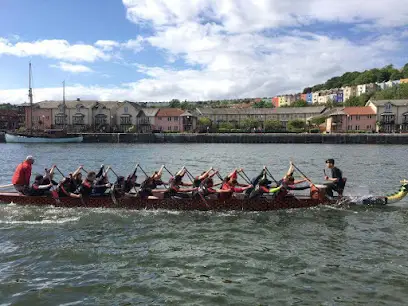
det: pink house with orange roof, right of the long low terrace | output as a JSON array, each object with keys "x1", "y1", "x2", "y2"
[{"x1": 326, "y1": 106, "x2": 376, "y2": 133}]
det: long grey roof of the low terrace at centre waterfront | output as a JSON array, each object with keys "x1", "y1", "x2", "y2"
[{"x1": 197, "y1": 106, "x2": 326, "y2": 116}]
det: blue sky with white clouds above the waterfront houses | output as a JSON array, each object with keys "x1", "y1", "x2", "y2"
[{"x1": 0, "y1": 0, "x2": 408, "y2": 104}]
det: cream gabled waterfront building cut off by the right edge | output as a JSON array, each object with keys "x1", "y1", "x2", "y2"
[{"x1": 366, "y1": 99, "x2": 408, "y2": 133}]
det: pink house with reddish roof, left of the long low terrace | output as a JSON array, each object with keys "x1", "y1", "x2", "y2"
[{"x1": 154, "y1": 108, "x2": 197, "y2": 132}]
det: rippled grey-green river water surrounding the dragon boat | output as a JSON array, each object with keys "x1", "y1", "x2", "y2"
[{"x1": 0, "y1": 144, "x2": 408, "y2": 305}]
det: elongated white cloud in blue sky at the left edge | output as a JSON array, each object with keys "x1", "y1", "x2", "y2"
[{"x1": 0, "y1": 38, "x2": 110, "y2": 62}]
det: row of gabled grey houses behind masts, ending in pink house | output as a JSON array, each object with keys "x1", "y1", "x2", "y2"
[{"x1": 25, "y1": 99, "x2": 197, "y2": 133}]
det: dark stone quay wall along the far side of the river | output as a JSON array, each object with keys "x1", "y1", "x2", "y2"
[{"x1": 0, "y1": 133, "x2": 408, "y2": 144}]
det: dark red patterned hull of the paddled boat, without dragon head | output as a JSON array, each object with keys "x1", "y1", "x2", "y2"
[{"x1": 0, "y1": 193, "x2": 336, "y2": 211}]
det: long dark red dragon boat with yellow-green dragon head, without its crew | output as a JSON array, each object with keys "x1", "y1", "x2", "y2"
[{"x1": 0, "y1": 180, "x2": 408, "y2": 211}]
